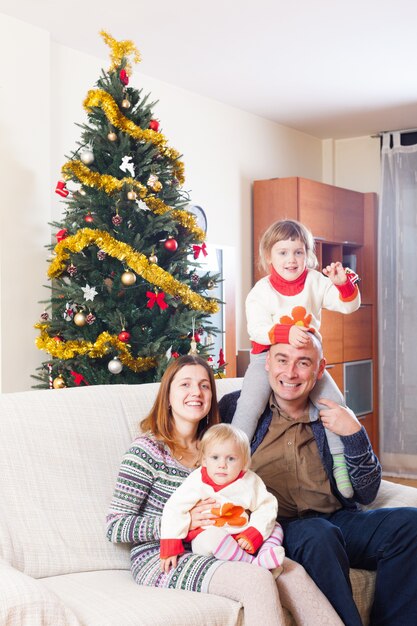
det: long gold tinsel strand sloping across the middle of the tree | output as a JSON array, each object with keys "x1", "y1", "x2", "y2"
[{"x1": 48, "y1": 228, "x2": 219, "y2": 313}]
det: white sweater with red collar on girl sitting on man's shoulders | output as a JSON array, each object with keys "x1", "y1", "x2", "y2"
[{"x1": 246, "y1": 268, "x2": 361, "y2": 354}]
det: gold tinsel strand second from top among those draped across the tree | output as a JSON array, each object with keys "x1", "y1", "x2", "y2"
[{"x1": 62, "y1": 160, "x2": 206, "y2": 241}]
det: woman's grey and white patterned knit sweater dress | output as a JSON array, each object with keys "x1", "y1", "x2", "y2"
[{"x1": 107, "y1": 435, "x2": 222, "y2": 592}]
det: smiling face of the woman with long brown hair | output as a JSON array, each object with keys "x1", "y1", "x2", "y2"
[{"x1": 169, "y1": 364, "x2": 212, "y2": 428}]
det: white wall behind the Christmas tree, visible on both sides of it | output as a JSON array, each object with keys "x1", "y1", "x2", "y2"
[{"x1": 0, "y1": 14, "x2": 322, "y2": 391}]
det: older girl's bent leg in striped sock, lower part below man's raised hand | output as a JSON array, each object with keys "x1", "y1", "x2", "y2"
[{"x1": 310, "y1": 371, "x2": 353, "y2": 498}]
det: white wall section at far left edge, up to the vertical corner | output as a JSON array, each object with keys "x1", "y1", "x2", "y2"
[{"x1": 0, "y1": 16, "x2": 51, "y2": 391}]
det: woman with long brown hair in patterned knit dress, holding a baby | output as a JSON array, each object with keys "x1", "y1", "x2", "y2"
[{"x1": 107, "y1": 355, "x2": 342, "y2": 626}]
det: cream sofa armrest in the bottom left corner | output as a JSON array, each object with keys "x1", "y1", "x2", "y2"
[{"x1": 0, "y1": 560, "x2": 81, "y2": 626}]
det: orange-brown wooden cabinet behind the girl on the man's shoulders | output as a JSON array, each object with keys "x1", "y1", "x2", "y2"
[{"x1": 253, "y1": 177, "x2": 378, "y2": 452}]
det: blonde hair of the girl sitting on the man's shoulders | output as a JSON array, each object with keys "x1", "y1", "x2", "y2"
[{"x1": 259, "y1": 220, "x2": 318, "y2": 273}]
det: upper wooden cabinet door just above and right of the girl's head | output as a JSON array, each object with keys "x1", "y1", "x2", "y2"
[{"x1": 298, "y1": 178, "x2": 334, "y2": 241}]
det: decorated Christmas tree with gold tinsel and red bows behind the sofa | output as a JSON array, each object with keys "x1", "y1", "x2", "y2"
[{"x1": 34, "y1": 32, "x2": 224, "y2": 388}]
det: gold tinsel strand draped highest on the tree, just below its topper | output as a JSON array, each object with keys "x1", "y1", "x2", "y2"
[{"x1": 84, "y1": 89, "x2": 184, "y2": 185}]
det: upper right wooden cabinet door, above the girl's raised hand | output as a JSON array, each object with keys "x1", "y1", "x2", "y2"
[{"x1": 333, "y1": 187, "x2": 364, "y2": 244}]
